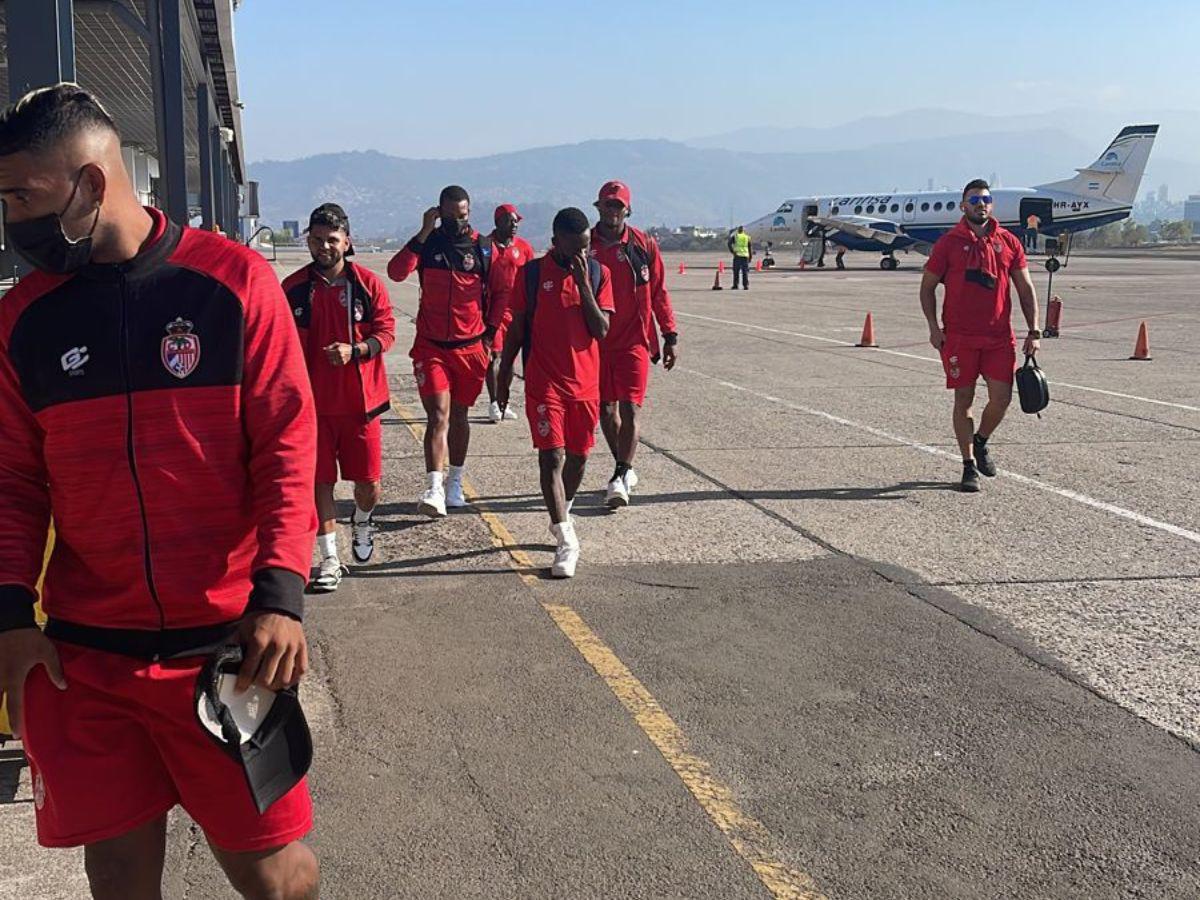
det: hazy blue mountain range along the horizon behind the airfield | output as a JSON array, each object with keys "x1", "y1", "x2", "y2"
[{"x1": 250, "y1": 109, "x2": 1200, "y2": 239}]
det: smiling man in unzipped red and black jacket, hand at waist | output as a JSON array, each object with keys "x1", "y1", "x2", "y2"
[{"x1": 283, "y1": 203, "x2": 396, "y2": 593}]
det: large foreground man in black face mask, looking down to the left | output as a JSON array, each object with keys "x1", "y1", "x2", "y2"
[{"x1": 0, "y1": 84, "x2": 317, "y2": 898}]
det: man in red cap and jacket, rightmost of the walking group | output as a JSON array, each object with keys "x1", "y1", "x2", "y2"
[{"x1": 592, "y1": 181, "x2": 679, "y2": 510}]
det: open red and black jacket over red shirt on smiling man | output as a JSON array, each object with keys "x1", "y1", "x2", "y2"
[{"x1": 283, "y1": 260, "x2": 396, "y2": 421}]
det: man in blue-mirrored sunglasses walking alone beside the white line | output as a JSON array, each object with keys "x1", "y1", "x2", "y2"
[{"x1": 920, "y1": 179, "x2": 1042, "y2": 493}]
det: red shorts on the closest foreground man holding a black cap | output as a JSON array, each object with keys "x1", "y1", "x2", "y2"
[{"x1": 23, "y1": 643, "x2": 312, "y2": 853}]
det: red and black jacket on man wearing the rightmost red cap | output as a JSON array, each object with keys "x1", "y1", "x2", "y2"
[{"x1": 592, "y1": 226, "x2": 677, "y2": 359}]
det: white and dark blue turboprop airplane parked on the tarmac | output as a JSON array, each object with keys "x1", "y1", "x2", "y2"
[{"x1": 745, "y1": 125, "x2": 1158, "y2": 271}]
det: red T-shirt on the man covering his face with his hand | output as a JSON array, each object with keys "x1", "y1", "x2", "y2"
[{"x1": 511, "y1": 253, "x2": 613, "y2": 401}]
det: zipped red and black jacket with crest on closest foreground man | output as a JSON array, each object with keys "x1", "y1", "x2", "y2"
[{"x1": 0, "y1": 210, "x2": 317, "y2": 659}]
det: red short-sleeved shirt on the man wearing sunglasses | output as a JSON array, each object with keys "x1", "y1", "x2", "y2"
[{"x1": 925, "y1": 218, "x2": 1027, "y2": 338}]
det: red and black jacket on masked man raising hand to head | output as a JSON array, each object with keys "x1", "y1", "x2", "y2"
[{"x1": 388, "y1": 228, "x2": 496, "y2": 349}]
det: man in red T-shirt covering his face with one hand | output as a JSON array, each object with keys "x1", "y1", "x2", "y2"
[{"x1": 497, "y1": 208, "x2": 613, "y2": 578}]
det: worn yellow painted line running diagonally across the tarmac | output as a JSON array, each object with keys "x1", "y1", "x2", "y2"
[{"x1": 394, "y1": 403, "x2": 826, "y2": 900}]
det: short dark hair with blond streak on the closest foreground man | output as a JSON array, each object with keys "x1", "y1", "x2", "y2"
[{"x1": 0, "y1": 82, "x2": 119, "y2": 156}]
